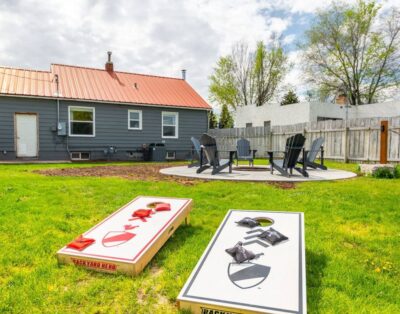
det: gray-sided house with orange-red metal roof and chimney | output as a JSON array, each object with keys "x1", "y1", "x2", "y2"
[{"x1": 0, "y1": 55, "x2": 211, "y2": 160}]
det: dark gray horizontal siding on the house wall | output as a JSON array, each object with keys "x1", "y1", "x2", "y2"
[{"x1": 0, "y1": 97, "x2": 207, "y2": 159}]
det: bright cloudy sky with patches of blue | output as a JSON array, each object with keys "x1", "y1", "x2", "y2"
[{"x1": 0, "y1": 0, "x2": 400, "y2": 108}]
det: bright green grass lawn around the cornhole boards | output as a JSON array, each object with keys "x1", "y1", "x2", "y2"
[{"x1": 0, "y1": 163, "x2": 400, "y2": 313}]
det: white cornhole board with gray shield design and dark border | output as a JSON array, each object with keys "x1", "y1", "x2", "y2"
[{"x1": 178, "y1": 210, "x2": 307, "y2": 314}]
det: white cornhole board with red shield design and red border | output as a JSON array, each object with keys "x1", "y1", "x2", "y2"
[{"x1": 57, "y1": 196, "x2": 192, "y2": 275}]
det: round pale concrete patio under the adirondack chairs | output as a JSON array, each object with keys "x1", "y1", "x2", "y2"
[{"x1": 160, "y1": 166, "x2": 357, "y2": 182}]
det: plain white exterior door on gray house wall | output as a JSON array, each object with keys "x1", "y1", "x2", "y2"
[{"x1": 15, "y1": 113, "x2": 38, "y2": 157}]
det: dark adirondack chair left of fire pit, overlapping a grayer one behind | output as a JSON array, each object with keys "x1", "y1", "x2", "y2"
[{"x1": 197, "y1": 134, "x2": 235, "y2": 174}]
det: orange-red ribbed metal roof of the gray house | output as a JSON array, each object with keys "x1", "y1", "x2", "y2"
[{"x1": 0, "y1": 64, "x2": 211, "y2": 109}]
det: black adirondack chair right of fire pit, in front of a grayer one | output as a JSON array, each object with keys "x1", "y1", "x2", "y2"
[{"x1": 268, "y1": 134, "x2": 308, "y2": 177}]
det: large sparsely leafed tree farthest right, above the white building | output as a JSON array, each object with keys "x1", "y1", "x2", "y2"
[{"x1": 302, "y1": 0, "x2": 400, "y2": 105}]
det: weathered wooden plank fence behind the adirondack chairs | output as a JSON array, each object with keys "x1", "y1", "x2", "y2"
[{"x1": 209, "y1": 116, "x2": 400, "y2": 162}]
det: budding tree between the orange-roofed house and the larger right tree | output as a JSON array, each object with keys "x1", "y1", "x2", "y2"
[{"x1": 209, "y1": 40, "x2": 288, "y2": 109}]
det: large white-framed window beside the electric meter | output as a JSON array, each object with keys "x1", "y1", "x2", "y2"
[{"x1": 68, "y1": 107, "x2": 95, "y2": 137}]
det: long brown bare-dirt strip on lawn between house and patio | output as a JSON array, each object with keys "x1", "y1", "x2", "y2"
[{"x1": 35, "y1": 164, "x2": 201, "y2": 185}]
